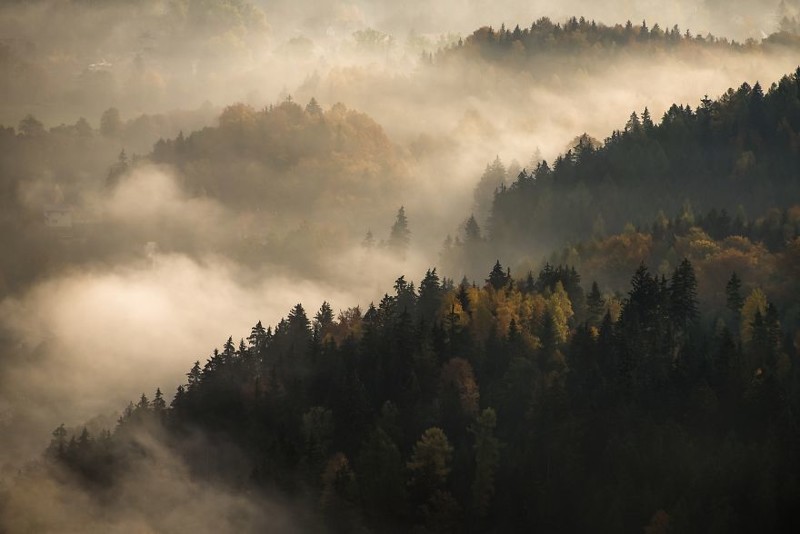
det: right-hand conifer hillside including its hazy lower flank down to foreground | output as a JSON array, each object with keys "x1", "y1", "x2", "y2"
[{"x1": 441, "y1": 71, "x2": 800, "y2": 287}]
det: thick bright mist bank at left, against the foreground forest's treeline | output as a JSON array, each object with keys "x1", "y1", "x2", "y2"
[{"x1": 0, "y1": 167, "x2": 440, "y2": 474}]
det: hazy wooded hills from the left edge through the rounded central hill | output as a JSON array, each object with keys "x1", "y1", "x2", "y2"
[{"x1": 0, "y1": 97, "x2": 409, "y2": 294}]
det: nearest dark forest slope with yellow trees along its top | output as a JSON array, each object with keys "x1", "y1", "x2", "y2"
[{"x1": 47, "y1": 260, "x2": 800, "y2": 532}]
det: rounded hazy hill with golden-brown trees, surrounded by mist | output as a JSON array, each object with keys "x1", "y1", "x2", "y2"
[{"x1": 152, "y1": 98, "x2": 407, "y2": 219}]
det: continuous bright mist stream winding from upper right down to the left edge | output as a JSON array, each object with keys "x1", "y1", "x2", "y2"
[{"x1": 0, "y1": 11, "x2": 793, "y2": 468}]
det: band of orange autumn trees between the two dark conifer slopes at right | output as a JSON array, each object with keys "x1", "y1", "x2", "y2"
[{"x1": 440, "y1": 204, "x2": 800, "y2": 318}]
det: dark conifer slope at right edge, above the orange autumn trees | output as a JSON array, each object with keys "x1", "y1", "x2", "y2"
[{"x1": 487, "y1": 68, "x2": 800, "y2": 249}]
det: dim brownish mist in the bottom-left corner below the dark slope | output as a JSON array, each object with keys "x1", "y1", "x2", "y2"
[{"x1": 0, "y1": 431, "x2": 313, "y2": 534}]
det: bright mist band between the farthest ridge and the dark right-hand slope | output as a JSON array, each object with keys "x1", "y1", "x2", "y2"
[{"x1": 295, "y1": 47, "x2": 796, "y2": 242}]
